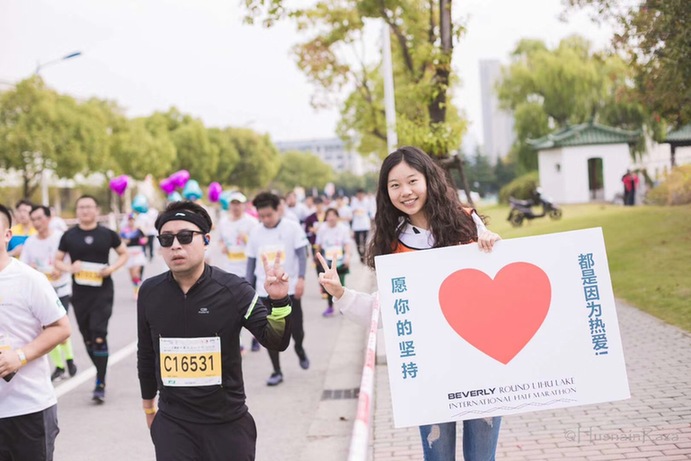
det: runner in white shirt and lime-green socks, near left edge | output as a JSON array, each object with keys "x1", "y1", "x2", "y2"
[{"x1": 20, "y1": 205, "x2": 77, "y2": 381}]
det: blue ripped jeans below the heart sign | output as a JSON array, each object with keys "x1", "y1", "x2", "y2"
[{"x1": 420, "y1": 416, "x2": 501, "y2": 461}]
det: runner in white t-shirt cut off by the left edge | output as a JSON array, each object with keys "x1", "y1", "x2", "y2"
[{"x1": 0, "y1": 205, "x2": 70, "y2": 461}]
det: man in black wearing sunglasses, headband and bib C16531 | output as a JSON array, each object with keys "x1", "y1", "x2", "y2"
[{"x1": 137, "y1": 201, "x2": 291, "y2": 461}]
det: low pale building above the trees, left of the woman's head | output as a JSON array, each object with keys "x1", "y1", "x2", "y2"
[{"x1": 276, "y1": 138, "x2": 371, "y2": 176}]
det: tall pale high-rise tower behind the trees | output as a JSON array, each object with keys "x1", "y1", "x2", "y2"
[{"x1": 480, "y1": 59, "x2": 515, "y2": 164}]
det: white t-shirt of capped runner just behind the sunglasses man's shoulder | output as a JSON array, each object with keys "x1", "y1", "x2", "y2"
[{"x1": 218, "y1": 214, "x2": 259, "y2": 277}]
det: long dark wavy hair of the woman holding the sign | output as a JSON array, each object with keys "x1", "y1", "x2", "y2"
[{"x1": 365, "y1": 146, "x2": 477, "y2": 269}]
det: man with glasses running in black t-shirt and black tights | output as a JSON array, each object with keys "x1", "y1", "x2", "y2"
[{"x1": 55, "y1": 195, "x2": 127, "y2": 403}]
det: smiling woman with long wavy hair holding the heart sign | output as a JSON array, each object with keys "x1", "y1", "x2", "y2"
[{"x1": 318, "y1": 146, "x2": 501, "y2": 461}]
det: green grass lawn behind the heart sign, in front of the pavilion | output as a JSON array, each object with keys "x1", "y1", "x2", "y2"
[{"x1": 478, "y1": 204, "x2": 691, "y2": 331}]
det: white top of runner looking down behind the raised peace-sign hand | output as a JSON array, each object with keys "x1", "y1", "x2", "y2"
[{"x1": 247, "y1": 219, "x2": 309, "y2": 297}]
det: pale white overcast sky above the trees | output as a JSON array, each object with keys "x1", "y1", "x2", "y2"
[{"x1": 0, "y1": 0, "x2": 611, "y2": 144}]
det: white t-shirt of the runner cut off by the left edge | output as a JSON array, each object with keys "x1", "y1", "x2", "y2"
[{"x1": 0, "y1": 259, "x2": 66, "y2": 418}]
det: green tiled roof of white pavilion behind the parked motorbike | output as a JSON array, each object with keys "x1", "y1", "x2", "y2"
[{"x1": 528, "y1": 122, "x2": 641, "y2": 150}]
